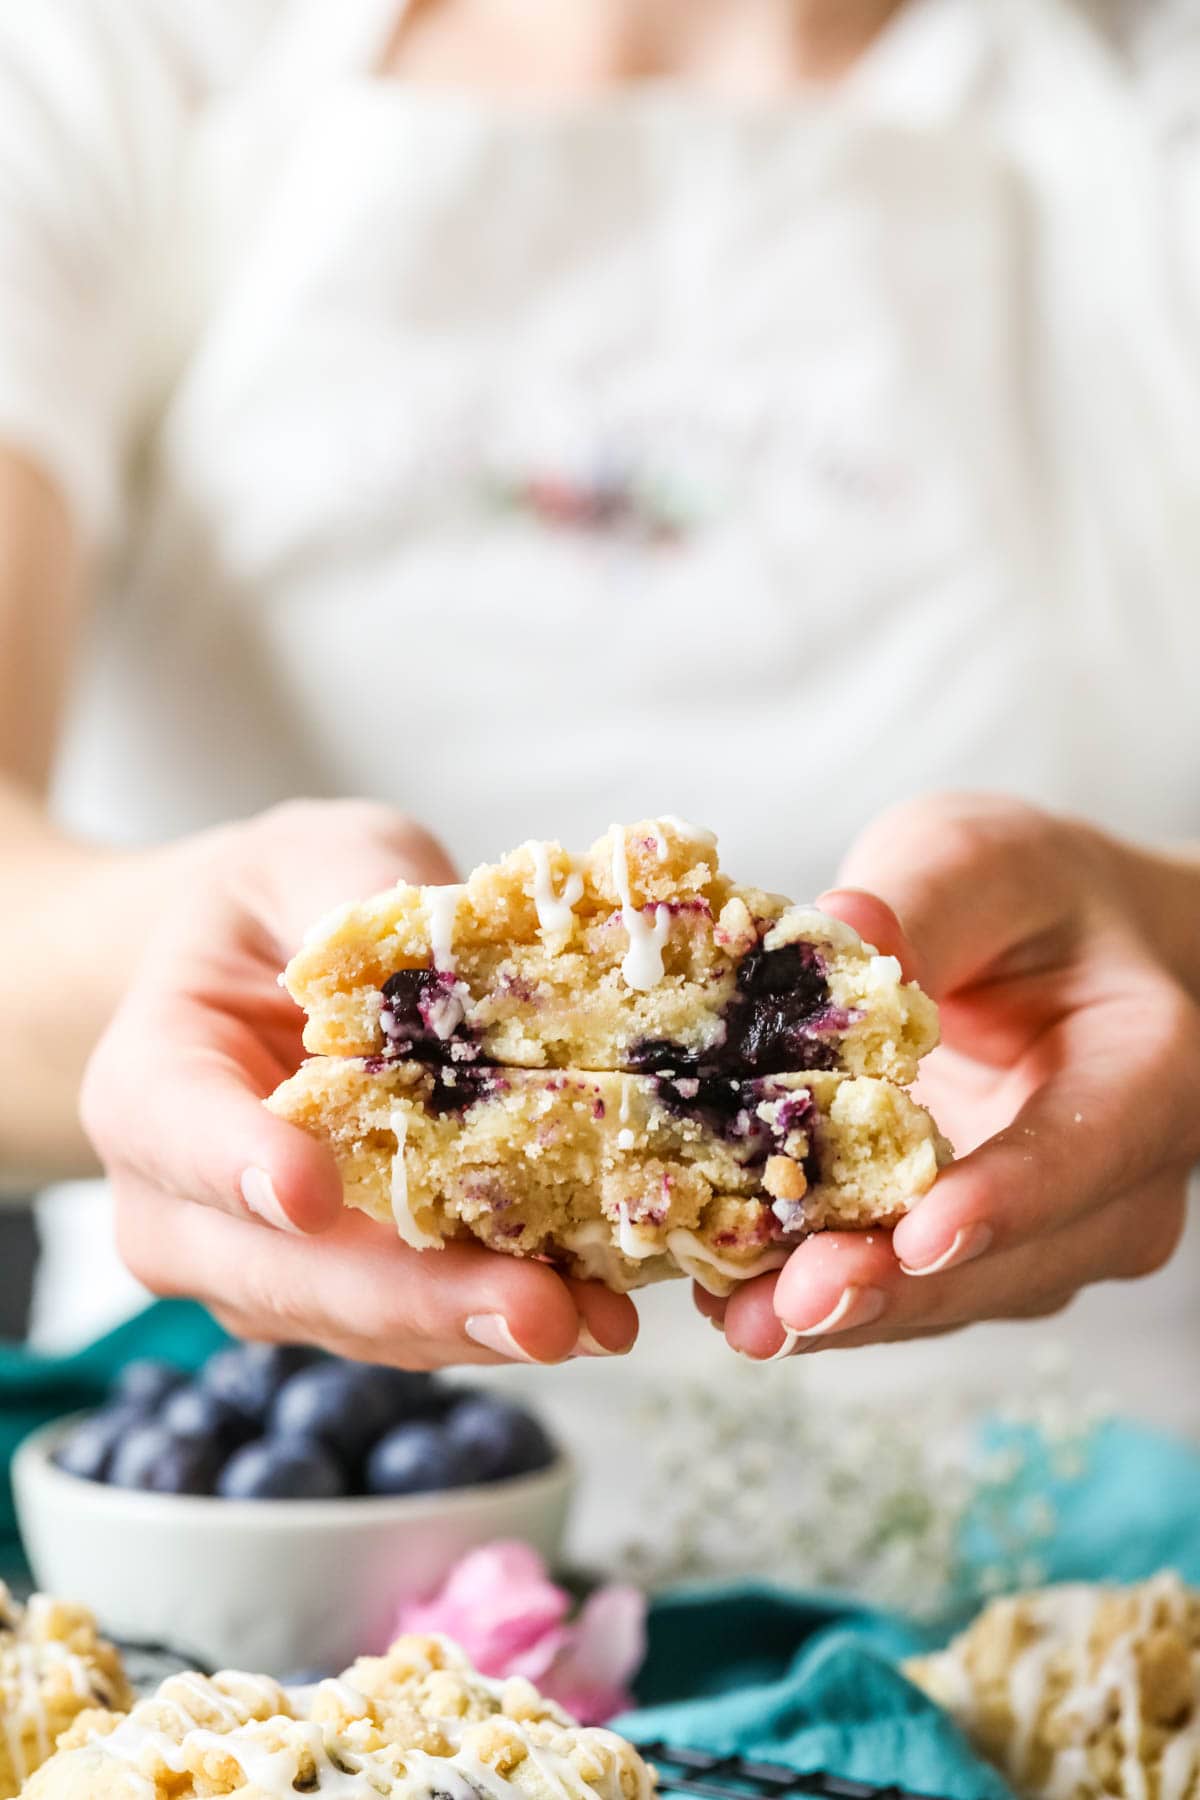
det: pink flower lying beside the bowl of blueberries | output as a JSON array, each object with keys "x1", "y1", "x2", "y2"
[{"x1": 396, "y1": 1543, "x2": 646, "y2": 1724}]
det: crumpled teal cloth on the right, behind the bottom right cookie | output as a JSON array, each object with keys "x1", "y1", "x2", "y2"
[{"x1": 617, "y1": 1422, "x2": 1200, "y2": 1800}]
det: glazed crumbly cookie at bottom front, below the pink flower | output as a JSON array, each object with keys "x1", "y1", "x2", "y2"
[{"x1": 25, "y1": 1638, "x2": 653, "y2": 1800}]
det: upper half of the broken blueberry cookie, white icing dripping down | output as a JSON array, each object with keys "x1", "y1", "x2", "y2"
[{"x1": 284, "y1": 817, "x2": 937, "y2": 1084}]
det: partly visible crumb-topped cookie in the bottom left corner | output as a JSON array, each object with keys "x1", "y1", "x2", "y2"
[{"x1": 0, "y1": 1582, "x2": 133, "y2": 1800}]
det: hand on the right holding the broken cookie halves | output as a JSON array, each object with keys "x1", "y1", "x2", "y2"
[{"x1": 696, "y1": 796, "x2": 1200, "y2": 1357}]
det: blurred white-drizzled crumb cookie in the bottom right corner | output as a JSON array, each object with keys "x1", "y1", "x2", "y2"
[{"x1": 907, "y1": 1575, "x2": 1200, "y2": 1800}]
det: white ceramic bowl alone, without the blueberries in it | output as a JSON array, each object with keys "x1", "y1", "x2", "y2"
[{"x1": 13, "y1": 1420, "x2": 572, "y2": 1676}]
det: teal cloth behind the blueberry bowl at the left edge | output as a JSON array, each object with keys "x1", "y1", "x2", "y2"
[{"x1": 0, "y1": 1300, "x2": 228, "y2": 1577}]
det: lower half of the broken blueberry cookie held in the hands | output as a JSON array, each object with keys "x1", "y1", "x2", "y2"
[{"x1": 268, "y1": 1057, "x2": 950, "y2": 1294}]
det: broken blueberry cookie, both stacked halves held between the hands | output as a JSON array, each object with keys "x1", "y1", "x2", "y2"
[{"x1": 268, "y1": 817, "x2": 950, "y2": 1294}]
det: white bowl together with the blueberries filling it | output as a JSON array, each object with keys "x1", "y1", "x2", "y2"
[{"x1": 13, "y1": 1345, "x2": 570, "y2": 1678}]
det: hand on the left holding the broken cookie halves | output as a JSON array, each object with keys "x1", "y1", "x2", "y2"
[{"x1": 83, "y1": 803, "x2": 637, "y2": 1368}]
